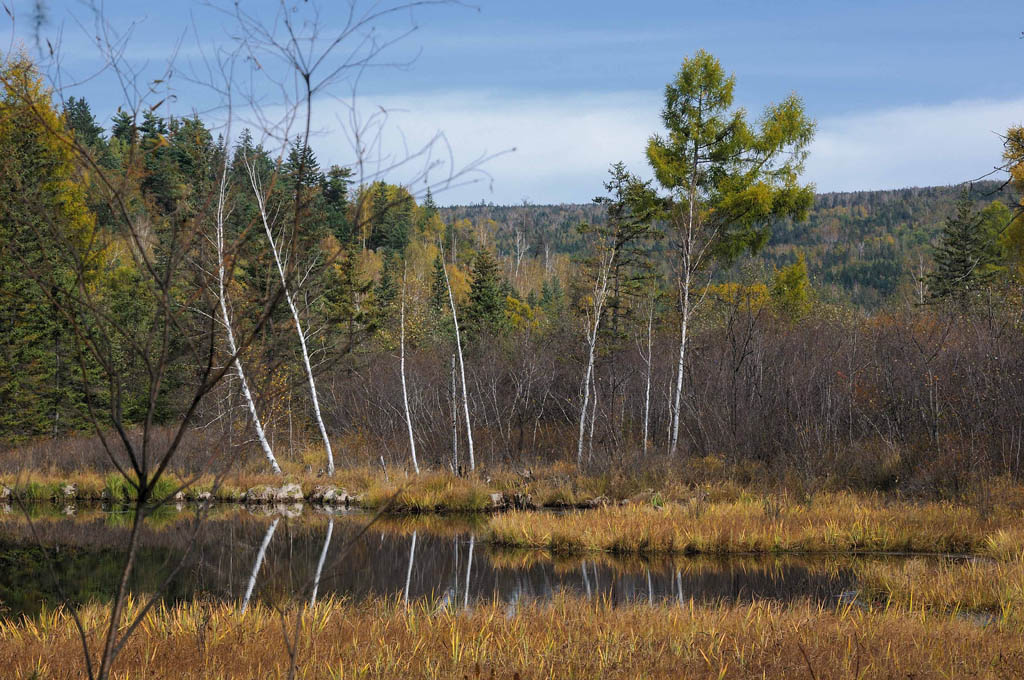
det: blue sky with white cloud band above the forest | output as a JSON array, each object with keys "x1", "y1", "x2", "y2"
[{"x1": 8, "y1": 0, "x2": 1024, "y2": 205}]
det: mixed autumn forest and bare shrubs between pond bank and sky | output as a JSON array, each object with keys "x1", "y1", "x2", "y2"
[{"x1": 0, "y1": 47, "x2": 1024, "y2": 487}]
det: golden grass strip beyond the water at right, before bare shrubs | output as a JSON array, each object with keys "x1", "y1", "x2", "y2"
[{"x1": 486, "y1": 493, "x2": 1024, "y2": 557}]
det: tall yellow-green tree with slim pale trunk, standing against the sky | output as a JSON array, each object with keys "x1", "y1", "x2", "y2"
[{"x1": 647, "y1": 50, "x2": 814, "y2": 454}]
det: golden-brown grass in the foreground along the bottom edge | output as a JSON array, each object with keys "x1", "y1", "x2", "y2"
[{"x1": 0, "y1": 596, "x2": 1024, "y2": 680}]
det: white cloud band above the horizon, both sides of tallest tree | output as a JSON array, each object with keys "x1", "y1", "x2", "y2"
[{"x1": 303, "y1": 91, "x2": 1024, "y2": 204}]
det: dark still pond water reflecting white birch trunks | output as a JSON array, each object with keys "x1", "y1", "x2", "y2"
[{"x1": 0, "y1": 505, "x2": 946, "y2": 617}]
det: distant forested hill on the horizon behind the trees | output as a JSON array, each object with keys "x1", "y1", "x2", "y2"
[{"x1": 441, "y1": 181, "x2": 1017, "y2": 308}]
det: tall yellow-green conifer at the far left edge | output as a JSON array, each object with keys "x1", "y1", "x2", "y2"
[{"x1": 0, "y1": 56, "x2": 100, "y2": 439}]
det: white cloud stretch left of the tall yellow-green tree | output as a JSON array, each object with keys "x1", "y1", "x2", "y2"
[{"x1": 305, "y1": 92, "x2": 659, "y2": 204}]
